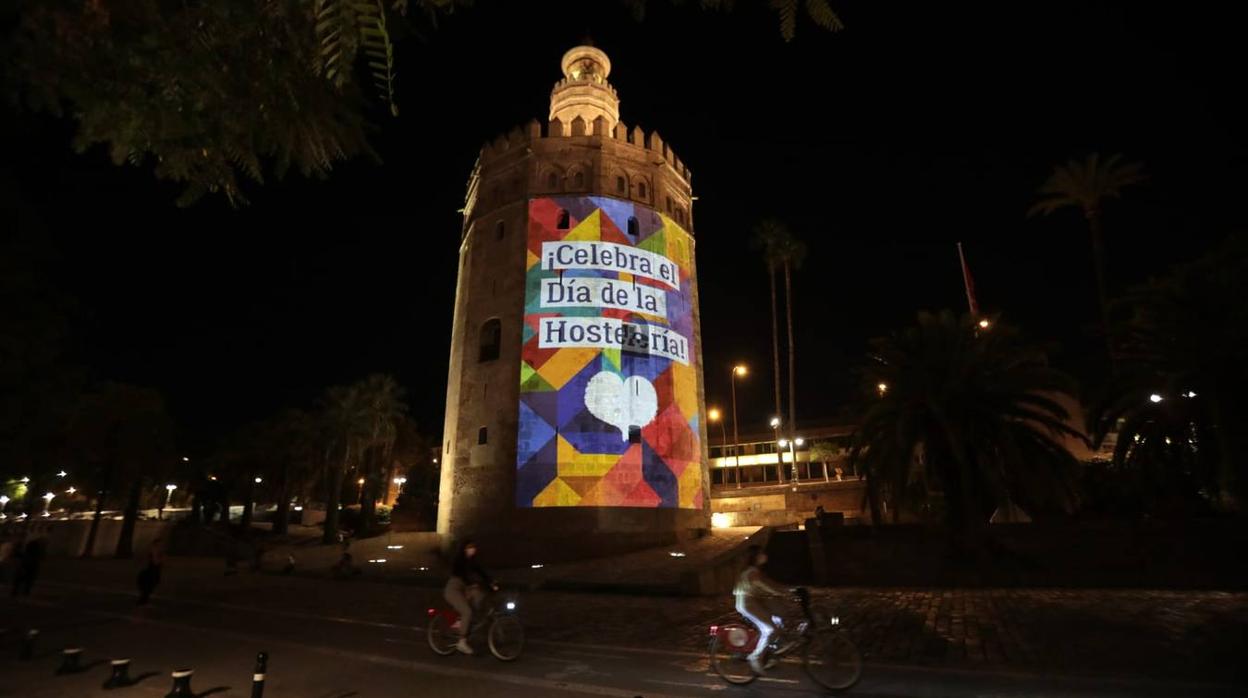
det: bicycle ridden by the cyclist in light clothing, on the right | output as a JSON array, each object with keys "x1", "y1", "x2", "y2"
[{"x1": 709, "y1": 588, "x2": 862, "y2": 692}]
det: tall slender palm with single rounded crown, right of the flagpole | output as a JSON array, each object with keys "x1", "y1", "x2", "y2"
[{"x1": 1027, "y1": 152, "x2": 1144, "y2": 358}]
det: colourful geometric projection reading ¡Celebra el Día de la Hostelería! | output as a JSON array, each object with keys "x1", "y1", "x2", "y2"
[{"x1": 517, "y1": 196, "x2": 704, "y2": 508}]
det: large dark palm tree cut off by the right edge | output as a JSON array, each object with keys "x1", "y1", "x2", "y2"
[{"x1": 1088, "y1": 236, "x2": 1248, "y2": 509}]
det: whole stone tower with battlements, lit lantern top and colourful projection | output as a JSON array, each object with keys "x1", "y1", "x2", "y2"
[{"x1": 438, "y1": 46, "x2": 709, "y2": 562}]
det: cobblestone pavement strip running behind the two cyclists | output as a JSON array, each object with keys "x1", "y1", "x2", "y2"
[{"x1": 26, "y1": 558, "x2": 1248, "y2": 683}]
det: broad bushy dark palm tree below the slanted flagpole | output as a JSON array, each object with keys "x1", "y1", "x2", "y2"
[{"x1": 850, "y1": 311, "x2": 1082, "y2": 544}]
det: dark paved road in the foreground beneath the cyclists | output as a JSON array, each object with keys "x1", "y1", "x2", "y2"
[{"x1": 0, "y1": 561, "x2": 1234, "y2": 698}]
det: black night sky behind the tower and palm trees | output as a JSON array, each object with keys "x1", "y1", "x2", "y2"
[{"x1": 0, "y1": 0, "x2": 1248, "y2": 448}]
